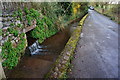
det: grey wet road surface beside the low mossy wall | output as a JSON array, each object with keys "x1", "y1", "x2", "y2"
[{"x1": 69, "y1": 10, "x2": 118, "y2": 78}]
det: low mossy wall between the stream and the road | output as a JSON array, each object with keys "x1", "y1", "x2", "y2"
[{"x1": 45, "y1": 14, "x2": 88, "y2": 78}]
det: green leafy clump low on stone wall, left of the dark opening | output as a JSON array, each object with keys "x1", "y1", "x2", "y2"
[{"x1": 1, "y1": 33, "x2": 25, "y2": 69}]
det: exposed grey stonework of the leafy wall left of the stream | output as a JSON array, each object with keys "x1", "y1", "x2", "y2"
[{"x1": 0, "y1": 2, "x2": 36, "y2": 80}]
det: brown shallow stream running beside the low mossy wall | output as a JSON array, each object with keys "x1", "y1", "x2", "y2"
[{"x1": 6, "y1": 22, "x2": 78, "y2": 78}]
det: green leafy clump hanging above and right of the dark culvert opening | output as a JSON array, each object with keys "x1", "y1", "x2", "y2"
[{"x1": 25, "y1": 8, "x2": 57, "y2": 43}]
